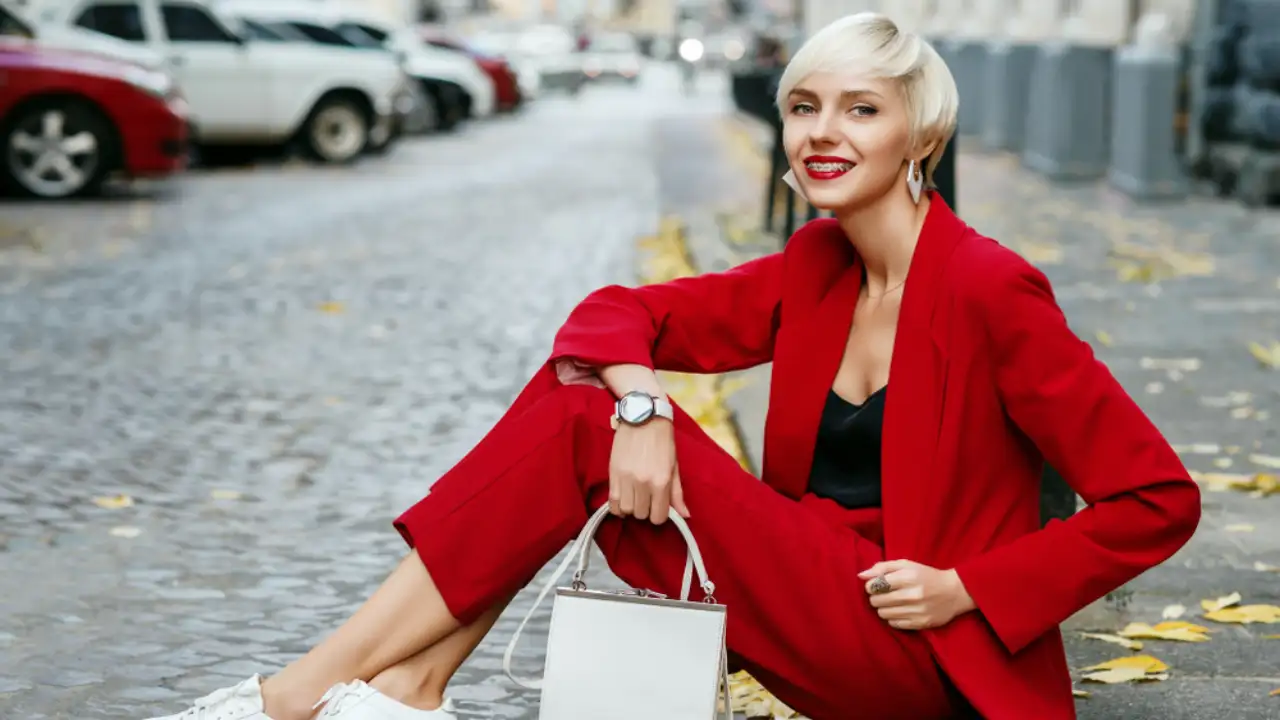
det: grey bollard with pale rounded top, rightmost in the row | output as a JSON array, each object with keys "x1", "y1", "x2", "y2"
[{"x1": 1107, "y1": 15, "x2": 1188, "y2": 200}]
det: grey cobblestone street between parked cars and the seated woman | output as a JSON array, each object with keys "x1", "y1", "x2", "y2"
[{"x1": 0, "y1": 64, "x2": 732, "y2": 720}]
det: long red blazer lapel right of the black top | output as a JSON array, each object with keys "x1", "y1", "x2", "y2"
[{"x1": 881, "y1": 192, "x2": 965, "y2": 561}]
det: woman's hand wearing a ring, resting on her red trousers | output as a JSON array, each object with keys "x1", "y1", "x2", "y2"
[{"x1": 858, "y1": 560, "x2": 975, "y2": 630}]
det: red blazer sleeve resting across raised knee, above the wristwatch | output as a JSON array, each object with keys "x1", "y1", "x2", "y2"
[{"x1": 552, "y1": 252, "x2": 783, "y2": 377}]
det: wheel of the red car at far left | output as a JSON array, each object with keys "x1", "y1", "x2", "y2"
[{"x1": 0, "y1": 97, "x2": 120, "y2": 200}]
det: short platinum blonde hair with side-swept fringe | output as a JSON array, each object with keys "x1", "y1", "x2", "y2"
[{"x1": 777, "y1": 13, "x2": 960, "y2": 184}]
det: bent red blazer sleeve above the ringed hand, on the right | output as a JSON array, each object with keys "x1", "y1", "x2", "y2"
[{"x1": 956, "y1": 259, "x2": 1201, "y2": 652}]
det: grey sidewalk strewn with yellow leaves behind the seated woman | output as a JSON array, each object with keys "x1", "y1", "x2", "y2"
[{"x1": 667, "y1": 109, "x2": 1280, "y2": 720}]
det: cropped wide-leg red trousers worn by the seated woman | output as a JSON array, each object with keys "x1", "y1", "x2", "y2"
[{"x1": 396, "y1": 370, "x2": 956, "y2": 720}]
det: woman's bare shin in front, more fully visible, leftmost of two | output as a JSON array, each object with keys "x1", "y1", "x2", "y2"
[{"x1": 262, "y1": 552, "x2": 461, "y2": 720}]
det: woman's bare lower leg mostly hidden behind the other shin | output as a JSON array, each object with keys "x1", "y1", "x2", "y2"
[{"x1": 369, "y1": 598, "x2": 511, "y2": 710}]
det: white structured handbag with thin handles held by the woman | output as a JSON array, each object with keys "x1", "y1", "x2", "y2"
[{"x1": 502, "y1": 505, "x2": 733, "y2": 720}]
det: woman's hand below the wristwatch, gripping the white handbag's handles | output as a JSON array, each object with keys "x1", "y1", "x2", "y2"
[{"x1": 609, "y1": 418, "x2": 689, "y2": 525}]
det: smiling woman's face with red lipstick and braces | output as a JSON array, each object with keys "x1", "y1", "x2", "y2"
[{"x1": 782, "y1": 73, "x2": 911, "y2": 210}]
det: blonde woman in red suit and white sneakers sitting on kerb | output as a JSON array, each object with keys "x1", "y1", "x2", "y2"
[{"x1": 149, "y1": 14, "x2": 1199, "y2": 720}]
